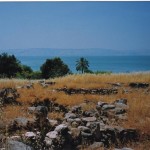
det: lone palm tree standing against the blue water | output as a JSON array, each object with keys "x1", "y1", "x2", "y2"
[{"x1": 76, "y1": 57, "x2": 89, "y2": 73}]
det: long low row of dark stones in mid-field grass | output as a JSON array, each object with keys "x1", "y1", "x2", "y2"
[{"x1": 57, "y1": 87, "x2": 118, "y2": 95}]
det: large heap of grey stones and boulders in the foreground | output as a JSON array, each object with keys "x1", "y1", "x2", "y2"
[{"x1": 5, "y1": 99, "x2": 139, "y2": 150}]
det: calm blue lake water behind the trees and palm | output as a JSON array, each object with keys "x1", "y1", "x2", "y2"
[{"x1": 17, "y1": 56, "x2": 150, "y2": 73}]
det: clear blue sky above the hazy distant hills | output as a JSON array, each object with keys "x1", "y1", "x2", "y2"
[{"x1": 0, "y1": 2, "x2": 150, "y2": 50}]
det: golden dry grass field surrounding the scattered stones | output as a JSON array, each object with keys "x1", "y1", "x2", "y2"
[{"x1": 0, "y1": 72, "x2": 150, "y2": 150}]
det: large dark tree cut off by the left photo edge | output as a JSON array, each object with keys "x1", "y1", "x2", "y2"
[{"x1": 0, "y1": 53, "x2": 22, "y2": 78}]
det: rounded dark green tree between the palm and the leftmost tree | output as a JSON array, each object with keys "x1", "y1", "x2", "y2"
[{"x1": 40, "y1": 57, "x2": 70, "y2": 79}]
